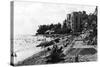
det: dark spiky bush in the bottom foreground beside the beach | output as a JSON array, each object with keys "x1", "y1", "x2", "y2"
[{"x1": 46, "y1": 45, "x2": 64, "y2": 63}]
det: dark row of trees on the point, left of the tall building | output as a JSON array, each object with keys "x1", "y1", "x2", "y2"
[{"x1": 36, "y1": 21, "x2": 71, "y2": 35}]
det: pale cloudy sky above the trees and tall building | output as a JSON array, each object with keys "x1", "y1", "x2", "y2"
[{"x1": 14, "y1": 1, "x2": 96, "y2": 35}]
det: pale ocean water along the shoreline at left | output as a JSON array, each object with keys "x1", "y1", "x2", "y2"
[{"x1": 13, "y1": 35, "x2": 52, "y2": 64}]
